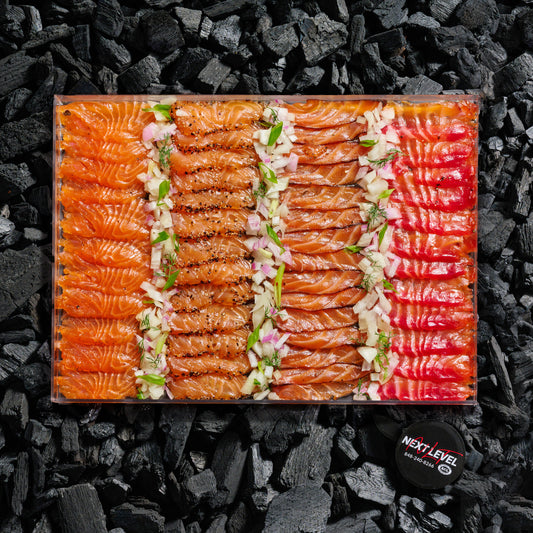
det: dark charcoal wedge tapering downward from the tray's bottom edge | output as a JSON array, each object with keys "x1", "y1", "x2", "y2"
[{"x1": 159, "y1": 406, "x2": 196, "y2": 470}]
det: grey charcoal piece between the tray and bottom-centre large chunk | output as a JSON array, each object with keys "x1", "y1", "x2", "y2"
[{"x1": 278, "y1": 424, "x2": 335, "y2": 489}]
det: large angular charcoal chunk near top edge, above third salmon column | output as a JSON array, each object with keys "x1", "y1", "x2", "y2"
[{"x1": 300, "y1": 13, "x2": 348, "y2": 67}]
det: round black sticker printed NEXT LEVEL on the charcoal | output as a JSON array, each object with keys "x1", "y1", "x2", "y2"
[{"x1": 396, "y1": 420, "x2": 465, "y2": 489}]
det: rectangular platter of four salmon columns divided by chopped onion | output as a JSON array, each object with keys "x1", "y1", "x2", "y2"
[{"x1": 52, "y1": 95, "x2": 479, "y2": 404}]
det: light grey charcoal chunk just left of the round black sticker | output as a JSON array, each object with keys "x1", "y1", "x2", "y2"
[{"x1": 344, "y1": 462, "x2": 396, "y2": 505}]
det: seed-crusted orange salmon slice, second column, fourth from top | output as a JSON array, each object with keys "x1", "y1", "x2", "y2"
[{"x1": 172, "y1": 166, "x2": 259, "y2": 193}]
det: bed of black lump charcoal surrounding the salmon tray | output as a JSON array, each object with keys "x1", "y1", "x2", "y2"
[{"x1": 0, "y1": 0, "x2": 533, "y2": 533}]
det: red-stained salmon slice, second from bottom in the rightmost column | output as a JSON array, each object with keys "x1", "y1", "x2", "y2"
[{"x1": 394, "y1": 355, "x2": 474, "y2": 381}]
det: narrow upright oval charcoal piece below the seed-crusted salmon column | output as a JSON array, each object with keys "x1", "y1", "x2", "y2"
[{"x1": 212, "y1": 431, "x2": 247, "y2": 506}]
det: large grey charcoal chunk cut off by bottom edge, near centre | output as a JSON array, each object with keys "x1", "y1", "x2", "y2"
[{"x1": 263, "y1": 486, "x2": 331, "y2": 533}]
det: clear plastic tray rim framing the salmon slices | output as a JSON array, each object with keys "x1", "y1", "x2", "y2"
[{"x1": 51, "y1": 95, "x2": 479, "y2": 405}]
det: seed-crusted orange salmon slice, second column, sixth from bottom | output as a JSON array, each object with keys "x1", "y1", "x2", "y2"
[{"x1": 176, "y1": 259, "x2": 254, "y2": 285}]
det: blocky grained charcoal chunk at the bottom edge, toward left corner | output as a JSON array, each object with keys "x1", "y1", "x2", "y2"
[{"x1": 57, "y1": 483, "x2": 107, "y2": 533}]
